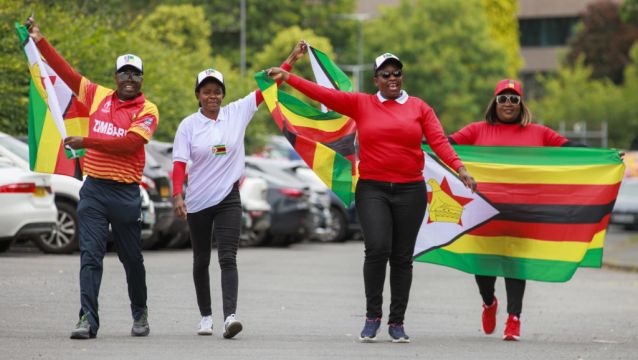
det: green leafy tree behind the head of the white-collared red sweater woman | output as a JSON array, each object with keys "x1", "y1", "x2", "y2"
[{"x1": 364, "y1": 0, "x2": 509, "y2": 131}]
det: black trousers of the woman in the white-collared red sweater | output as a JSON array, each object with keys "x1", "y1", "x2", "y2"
[{"x1": 355, "y1": 180, "x2": 427, "y2": 324}]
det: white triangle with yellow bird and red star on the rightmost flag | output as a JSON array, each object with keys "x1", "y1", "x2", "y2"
[{"x1": 414, "y1": 152, "x2": 498, "y2": 256}]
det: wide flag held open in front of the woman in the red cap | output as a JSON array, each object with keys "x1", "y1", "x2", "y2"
[{"x1": 414, "y1": 146, "x2": 624, "y2": 282}]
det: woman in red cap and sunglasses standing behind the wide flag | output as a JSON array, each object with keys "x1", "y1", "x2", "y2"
[{"x1": 449, "y1": 79, "x2": 579, "y2": 340}]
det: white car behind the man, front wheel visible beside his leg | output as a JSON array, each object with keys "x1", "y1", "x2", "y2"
[{"x1": 0, "y1": 132, "x2": 155, "y2": 254}]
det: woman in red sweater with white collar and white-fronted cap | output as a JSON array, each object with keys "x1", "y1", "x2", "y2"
[{"x1": 268, "y1": 53, "x2": 476, "y2": 342}]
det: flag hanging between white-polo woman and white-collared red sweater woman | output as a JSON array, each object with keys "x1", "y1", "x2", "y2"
[{"x1": 255, "y1": 47, "x2": 357, "y2": 205}]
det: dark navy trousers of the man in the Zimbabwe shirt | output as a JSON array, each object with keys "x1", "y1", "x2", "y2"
[{"x1": 78, "y1": 177, "x2": 146, "y2": 335}]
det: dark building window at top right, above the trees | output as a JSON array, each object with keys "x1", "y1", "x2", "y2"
[{"x1": 519, "y1": 17, "x2": 580, "y2": 47}]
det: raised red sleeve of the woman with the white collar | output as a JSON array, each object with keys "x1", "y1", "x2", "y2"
[{"x1": 286, "y1": 74, "x2": 359, "y2": 118}]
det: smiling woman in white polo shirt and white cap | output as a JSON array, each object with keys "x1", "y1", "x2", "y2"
[{"x1": 173, "y1": 42, "x2": 306, "y2": 339}]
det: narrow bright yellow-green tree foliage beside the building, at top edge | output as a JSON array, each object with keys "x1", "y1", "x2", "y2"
[{"x1": 481, "y1": 0, "x2": 523, "y2": 78}]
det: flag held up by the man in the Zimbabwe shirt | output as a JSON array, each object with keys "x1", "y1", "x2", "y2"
[{"x1": 15, "y1": 23, "x2": 89, "y2": 177}]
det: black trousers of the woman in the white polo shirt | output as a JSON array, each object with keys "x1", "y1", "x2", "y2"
[{"x1": 188, "y1": 183, "x2": 242, "y2": 318}]
